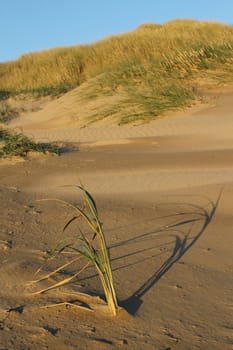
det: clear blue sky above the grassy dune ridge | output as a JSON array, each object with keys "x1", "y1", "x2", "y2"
[{"x1": 0, "y1": 0, "x2": 233, "y2": 62}]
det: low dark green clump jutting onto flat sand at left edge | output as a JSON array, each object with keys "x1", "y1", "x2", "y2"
[{"x1": 0, "y1": 128, "x2": 59, "y2": 158}]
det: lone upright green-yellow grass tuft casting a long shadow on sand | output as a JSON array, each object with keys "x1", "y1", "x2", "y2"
[{"x1": 33, "y1": 185, "x2": 119, "y2": 316}]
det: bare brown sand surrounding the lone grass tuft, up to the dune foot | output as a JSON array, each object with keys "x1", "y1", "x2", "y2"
[{"x1": 0, "y1": 87, "x2": 233, "y2": 350}]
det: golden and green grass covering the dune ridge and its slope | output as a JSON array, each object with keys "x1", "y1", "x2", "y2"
[{"x1": 0, "y1": 20, "x2": 233, "y2": 124}]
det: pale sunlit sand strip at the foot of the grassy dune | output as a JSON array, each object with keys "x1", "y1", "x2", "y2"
[{"x1": 11, "y1": 86, "x2": 233, "y2": 148}]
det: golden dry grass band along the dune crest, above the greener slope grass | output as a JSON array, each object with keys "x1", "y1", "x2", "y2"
[{"x1": 0, "y1": 20, "x2": 233, "y2": 90}]
